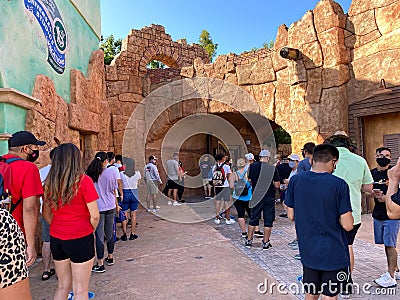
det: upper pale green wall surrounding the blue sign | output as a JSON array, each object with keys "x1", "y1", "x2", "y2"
[{"x1": 0, "y1": 0, "x2": 100, "y2": 102}]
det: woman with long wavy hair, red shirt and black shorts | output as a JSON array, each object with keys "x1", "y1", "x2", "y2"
[{"x1": 43, "y1": 143, "x2": 99, "y2": 300}]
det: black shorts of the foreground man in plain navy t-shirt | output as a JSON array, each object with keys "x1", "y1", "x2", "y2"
[{"x1": 303, "y1": 266, "x2": 353, "y2": 297}]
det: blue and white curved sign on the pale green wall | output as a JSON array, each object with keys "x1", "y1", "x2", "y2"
[{"x1": 24, "y1": 0, "x2": 68, "y2": 74}]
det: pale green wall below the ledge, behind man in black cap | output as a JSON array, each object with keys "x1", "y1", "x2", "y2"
[{"x1": 0, "y1": 103, "x2": 26, "y2": 155}]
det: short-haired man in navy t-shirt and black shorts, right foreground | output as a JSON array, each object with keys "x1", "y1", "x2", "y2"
[{"x1": 285, "y1": 144, "x2": 354, "y2": 299}]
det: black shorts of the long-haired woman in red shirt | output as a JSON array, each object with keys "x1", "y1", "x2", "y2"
[{"x1": 50, "y1": 233, "x2": 94, "y2": 264}]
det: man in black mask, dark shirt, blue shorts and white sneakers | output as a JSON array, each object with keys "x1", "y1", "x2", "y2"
[{"x1": 371, "y1": 147, "x2": 400, "y2": 288}]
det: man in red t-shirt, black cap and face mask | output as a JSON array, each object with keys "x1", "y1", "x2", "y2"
[{"x1": 3, "y1": 131, "x2": 46, "y2": 266}]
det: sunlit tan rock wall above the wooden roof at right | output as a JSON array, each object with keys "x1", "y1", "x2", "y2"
[{"x1": 345, "y1": 0, "x2": 400, "y2": 104}]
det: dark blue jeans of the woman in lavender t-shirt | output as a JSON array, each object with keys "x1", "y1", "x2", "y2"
[{"x1": 96, "y1": 209, "x2": 115, "y2": 259}]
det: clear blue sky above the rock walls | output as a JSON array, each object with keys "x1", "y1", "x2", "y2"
[{"x1": 100, "y1": 0, "x2": 351, "y2": 54}]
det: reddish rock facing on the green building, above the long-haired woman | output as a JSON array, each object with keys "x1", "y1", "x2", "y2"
[{"x1": 26, "y1": 50, "x2": 108, "y2": 166}]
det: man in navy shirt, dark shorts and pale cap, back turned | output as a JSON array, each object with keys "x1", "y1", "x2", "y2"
[{"x1": 245, "y1": 150, "x2": 280, "y2": 250}]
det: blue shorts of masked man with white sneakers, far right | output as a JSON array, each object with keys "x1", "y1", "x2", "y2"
[{"x1": 374, "y1": 219, "x2": 400, "y2": 247}]
